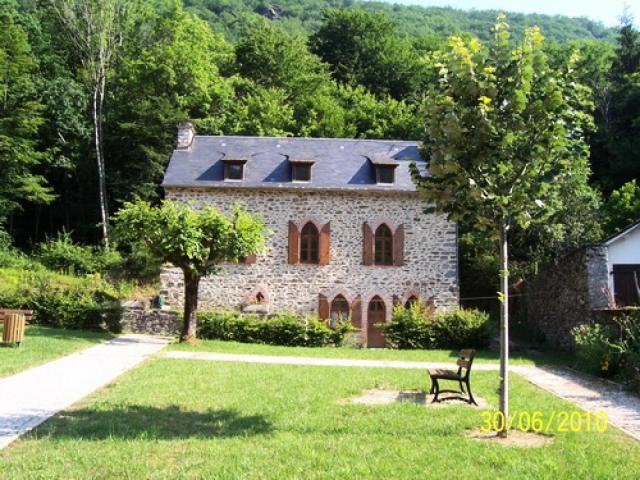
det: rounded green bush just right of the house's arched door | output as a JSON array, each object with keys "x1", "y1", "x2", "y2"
[{"x1": 383, "y1": 302, "x2": 435, "y2": 349}]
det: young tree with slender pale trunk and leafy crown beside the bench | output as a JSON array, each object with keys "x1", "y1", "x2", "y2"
[{"x1": 413, "y1": 15, "x2": 592, "y2": 435}]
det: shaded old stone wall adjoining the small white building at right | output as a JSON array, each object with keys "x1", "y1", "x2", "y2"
[{"x1": 526, "y1": 246, "x2": 610, "y2": 350}]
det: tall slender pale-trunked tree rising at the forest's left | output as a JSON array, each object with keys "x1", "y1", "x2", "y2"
[{"x1": 53, "y1": 0, "x2": 134, "y2": 249}]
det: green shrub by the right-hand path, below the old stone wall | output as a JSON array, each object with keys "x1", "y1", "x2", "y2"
[{"x1": 572, "y1": 323, "x2": 623, "y2": 377}]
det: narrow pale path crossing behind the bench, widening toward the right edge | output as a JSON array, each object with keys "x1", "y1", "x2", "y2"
[{"x1": 165, "y1": 351, "x2": 640, "y2": 440}]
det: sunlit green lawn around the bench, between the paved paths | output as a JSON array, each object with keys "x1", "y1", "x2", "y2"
[{"x1": 0, "y1": 359, "x2": 640, "y2": 480}]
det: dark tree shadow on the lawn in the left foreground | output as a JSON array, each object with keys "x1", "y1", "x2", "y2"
[{"x1": 38, "y1": 405, "x2": 273, "y2": 440}]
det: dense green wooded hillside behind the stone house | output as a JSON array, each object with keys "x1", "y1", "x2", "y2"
[{"x1": 0, "y1": 0, "x2": 640, "y2": 344}]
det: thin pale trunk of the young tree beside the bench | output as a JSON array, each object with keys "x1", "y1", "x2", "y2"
[{"x1": 499, "y1": 220, "x2": 509, "y2": 437}]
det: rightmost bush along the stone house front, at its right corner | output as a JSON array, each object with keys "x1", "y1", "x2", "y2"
[{"x1": 433, "y1": 308, "x2": 490, "y2": 348}]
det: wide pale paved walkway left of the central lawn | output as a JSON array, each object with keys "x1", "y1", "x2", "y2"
[{"x1": 0, "y1": 335, "x2": 168, "y2": 449}]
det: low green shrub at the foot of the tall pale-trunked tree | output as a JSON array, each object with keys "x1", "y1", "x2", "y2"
[{"x1": 36, "y1": 232, "x2": 122, "y2": 275}]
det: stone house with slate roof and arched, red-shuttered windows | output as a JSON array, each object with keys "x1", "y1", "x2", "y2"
[{"x1": 161, "y1": 122, "x2": 459, "y2": 346}]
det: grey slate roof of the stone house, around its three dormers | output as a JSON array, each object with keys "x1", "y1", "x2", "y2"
[{"x1": 162, "y1": 136, "x2": 425, "y2": 192}]
